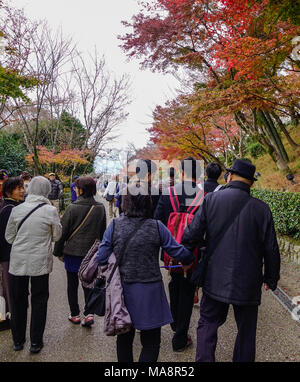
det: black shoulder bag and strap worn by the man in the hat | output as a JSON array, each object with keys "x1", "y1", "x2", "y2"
[{"x1": 190, "y1": 197, "x2": 251, "y2": 287}]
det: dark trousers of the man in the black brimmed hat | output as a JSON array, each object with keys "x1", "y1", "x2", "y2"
[{"x1": 196, "y1": 293, "x2": 258, "y2": 362}]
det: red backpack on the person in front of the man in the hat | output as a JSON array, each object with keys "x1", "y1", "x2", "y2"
[{"x1": 164, "y1": 187, "x2": 205, "y2": 272}]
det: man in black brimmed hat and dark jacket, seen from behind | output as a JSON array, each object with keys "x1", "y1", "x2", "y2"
[{"x1": 182, "y1": 159, "x2": 280, "y2": 362}]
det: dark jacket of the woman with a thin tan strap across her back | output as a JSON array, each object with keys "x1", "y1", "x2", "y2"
[{"x1": 53, "y1": 196, "x2": 106, "y2": 257}]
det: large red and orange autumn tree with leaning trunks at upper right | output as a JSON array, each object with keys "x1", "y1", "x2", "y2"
[{"x1": 120, "y1": 0, "x2": 300, "y2": 170}]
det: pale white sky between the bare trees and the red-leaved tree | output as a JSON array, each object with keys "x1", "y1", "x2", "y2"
[{"x1": 10, "y1": 0, "x2": 178, "y2": 148}]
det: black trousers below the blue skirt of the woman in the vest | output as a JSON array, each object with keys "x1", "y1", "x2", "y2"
[{"x1": 117, "y1": 328, "x2": 161, "y2": 362}]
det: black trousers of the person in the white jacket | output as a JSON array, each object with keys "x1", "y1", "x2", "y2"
[{"x1": 10, "y1": 274, "x2": 49, "y2": 344}]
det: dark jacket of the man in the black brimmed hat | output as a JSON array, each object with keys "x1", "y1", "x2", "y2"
[{"x1": 182, "y1": 181, "x2": 280, "y2": 305}]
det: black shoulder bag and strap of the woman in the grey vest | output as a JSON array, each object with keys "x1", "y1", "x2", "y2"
[{"x1": 84, "y1": 219, "x2": 147, "y2": 317}]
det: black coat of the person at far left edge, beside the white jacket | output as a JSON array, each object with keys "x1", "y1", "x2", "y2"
[{"x1": 0, "y1": 199, "x2": 19, "y2": 262}]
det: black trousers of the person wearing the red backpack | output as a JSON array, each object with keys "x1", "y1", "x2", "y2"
[{"x1": 169, "y1": 272, "x2": 196, "y2": 350}]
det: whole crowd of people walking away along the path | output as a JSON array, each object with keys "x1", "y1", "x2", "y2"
[{"x1": 0, "y1": 157, "x2": 280, "y2": 362}]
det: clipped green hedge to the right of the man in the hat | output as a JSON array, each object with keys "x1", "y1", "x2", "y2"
[{"x1": 251, "y1": 189, "x2": 300, "y2": 239}]
